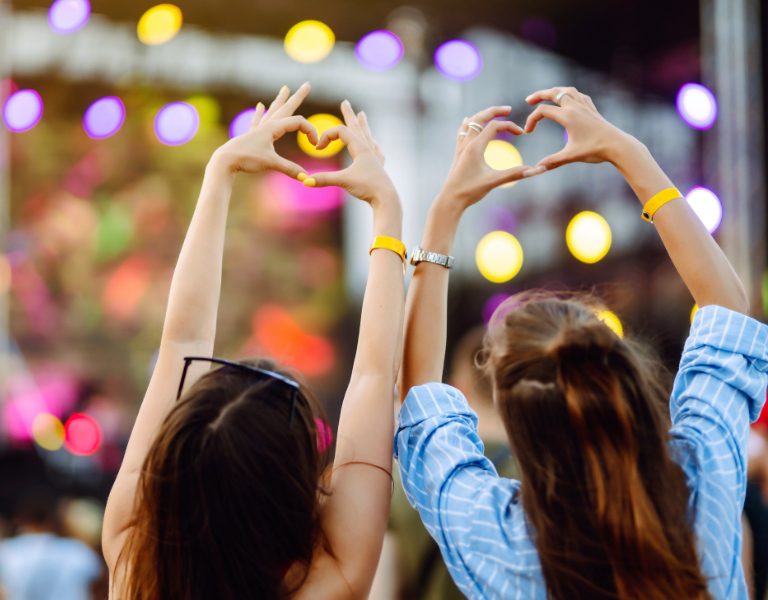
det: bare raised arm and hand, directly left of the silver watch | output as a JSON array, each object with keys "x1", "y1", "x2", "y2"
[{"x1": 304, "y1": 101, "x2": 404, "y2": 598}]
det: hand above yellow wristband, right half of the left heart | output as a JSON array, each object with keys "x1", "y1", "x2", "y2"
[{"x1": 304, "y1": 100, "x2": 397, "y2": 204}]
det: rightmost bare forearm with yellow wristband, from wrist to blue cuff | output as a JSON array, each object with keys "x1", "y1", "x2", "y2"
[{"x1": 612, "y1": 137, "x2": 749, "y2": 312}]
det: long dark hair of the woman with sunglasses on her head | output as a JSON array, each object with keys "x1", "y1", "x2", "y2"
[{"x1": 117, "y1": 361, "x2": 327, "y2": 600}]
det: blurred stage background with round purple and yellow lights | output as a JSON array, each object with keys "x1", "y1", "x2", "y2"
[{"x1": 0, "y1": 0, "x2": 768, "y2": 596}]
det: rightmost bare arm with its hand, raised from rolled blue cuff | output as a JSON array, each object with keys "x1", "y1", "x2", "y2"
[{"x1": 526, "y1": 87, "x2": 749, "y2": 313}]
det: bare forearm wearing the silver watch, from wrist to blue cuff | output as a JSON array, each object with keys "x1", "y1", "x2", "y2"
[{"x1": 399, "y1": 193, "x2": 462, "y2": 401}]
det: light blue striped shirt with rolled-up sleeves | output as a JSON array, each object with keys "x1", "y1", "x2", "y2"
[{"x1": 395, "y1": 306, "x2": 768, "y2": 600}]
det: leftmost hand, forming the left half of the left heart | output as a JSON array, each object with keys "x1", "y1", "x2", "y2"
[{"x1": 214, "y1": 83, "x2": 317, "y2": 178}]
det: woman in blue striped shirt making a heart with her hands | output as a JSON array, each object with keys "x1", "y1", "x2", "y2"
[{"x1": 395, "y1": 88, "x2": 768, "y2": 600}]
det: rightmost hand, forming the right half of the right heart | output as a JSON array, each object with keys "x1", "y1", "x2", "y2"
[{"x1": 525, "y1": 87, "x2": 628, "y2": 170}]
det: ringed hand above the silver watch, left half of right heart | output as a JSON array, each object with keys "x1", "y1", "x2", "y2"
[{"x1": 441, "y1": 106, "x2": 545, "y2": 208}]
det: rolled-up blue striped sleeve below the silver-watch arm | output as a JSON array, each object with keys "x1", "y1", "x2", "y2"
[{"x1": 395, "y1": 383, "x2": 516, "y2": 597}]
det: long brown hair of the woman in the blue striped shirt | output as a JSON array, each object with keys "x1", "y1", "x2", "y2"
[{"x1": 481, "y1": 294, "x2": 709, "y2": 600}]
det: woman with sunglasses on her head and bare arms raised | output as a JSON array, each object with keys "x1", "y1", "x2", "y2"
[{"x1": 103, "y1": 84, "x2": 404, "y2": 600}]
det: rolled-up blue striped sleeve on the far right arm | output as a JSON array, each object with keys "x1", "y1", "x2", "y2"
[{"x1": 670, "y1": 306, "x2": 768, "y2": 502}]
